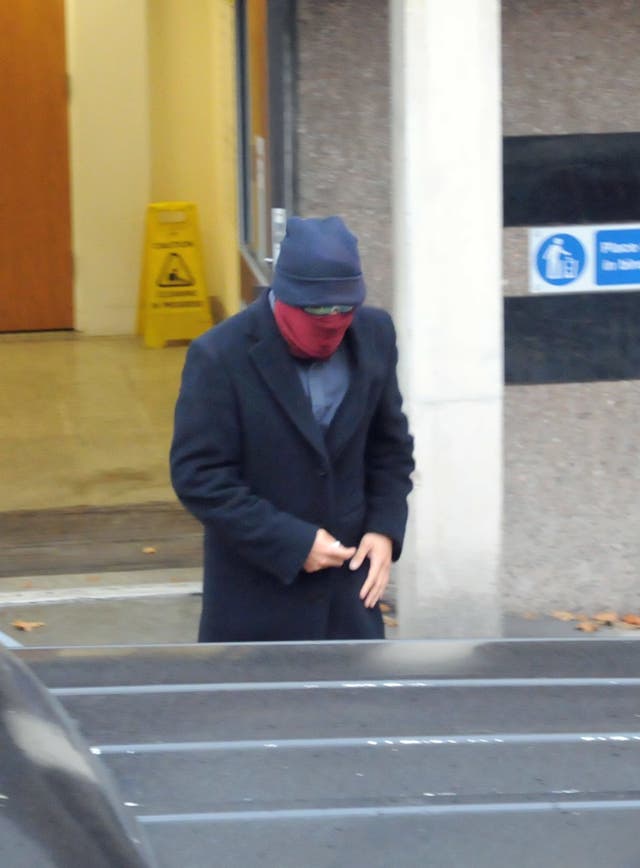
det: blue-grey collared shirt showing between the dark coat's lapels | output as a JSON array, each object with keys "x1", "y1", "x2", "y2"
[{"x1": 269, "y1": 291, "x2": 349, "y2": 430}]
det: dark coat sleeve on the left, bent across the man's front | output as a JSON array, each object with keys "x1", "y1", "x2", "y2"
[{"x1": 170, "y1": 342, "x2": 318, "y2": 584}]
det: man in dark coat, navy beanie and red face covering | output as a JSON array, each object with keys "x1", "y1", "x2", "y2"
[{"x1": 171, "y1": 217, "x2": 413, "y2": 642}]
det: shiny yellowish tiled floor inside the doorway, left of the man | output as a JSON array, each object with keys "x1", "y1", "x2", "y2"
[{"x1": 0, "y1": 333, "x2": 186, "y2": 511}]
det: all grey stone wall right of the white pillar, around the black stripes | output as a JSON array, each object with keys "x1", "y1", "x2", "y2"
[{"x1": 502, "y1": 0, "x2": 640, "y2": 611}]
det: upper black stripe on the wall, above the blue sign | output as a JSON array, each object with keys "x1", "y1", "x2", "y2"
[{"x1": 503, "y1": 133, "x2": 640, "y2": 226}]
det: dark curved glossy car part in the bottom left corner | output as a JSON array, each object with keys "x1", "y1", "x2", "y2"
[{"x1": 0, "y1": 649, "x2": 156, "y2": 868}]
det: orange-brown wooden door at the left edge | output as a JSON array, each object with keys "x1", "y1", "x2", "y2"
[{"x1": 0, "y1": 0, "x2": 73, "y2": 332}]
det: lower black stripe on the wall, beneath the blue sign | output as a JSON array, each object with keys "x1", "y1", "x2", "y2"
[{"x1": 504, "y1": 291, "x2": 640, "y2": 385}]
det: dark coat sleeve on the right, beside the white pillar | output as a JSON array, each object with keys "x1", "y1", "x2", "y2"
[{"x1": 365, "y1": 314, "x2": 415, "y2": 561}]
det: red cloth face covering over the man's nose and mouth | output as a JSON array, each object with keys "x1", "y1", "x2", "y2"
[{"x1": 273, "y1": 299, "x2": 354, "y2": 359}]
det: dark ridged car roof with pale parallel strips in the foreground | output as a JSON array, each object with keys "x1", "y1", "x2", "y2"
[{"x1": 17, "y1": 639, "x2": 640, "y2": 868}]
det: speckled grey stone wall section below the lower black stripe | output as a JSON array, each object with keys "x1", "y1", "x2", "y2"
[{"x1": 503, "y1": 381, "x2": 640, "y2": 614}]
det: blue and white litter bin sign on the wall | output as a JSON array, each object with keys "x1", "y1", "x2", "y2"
[{"x1": 529, "y1": 224, "x2": 640, "y2": 293}]
